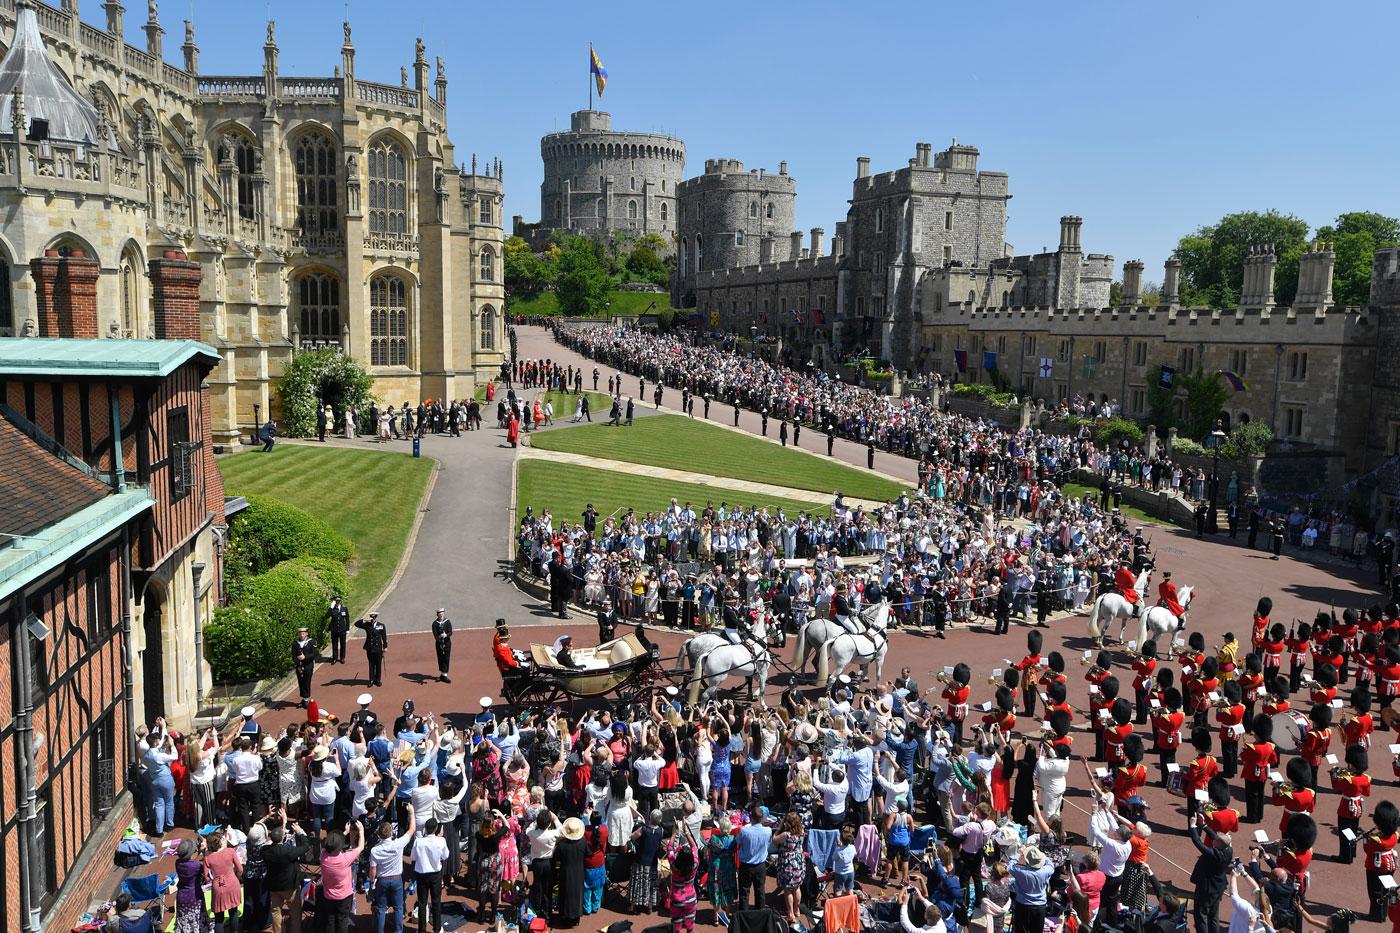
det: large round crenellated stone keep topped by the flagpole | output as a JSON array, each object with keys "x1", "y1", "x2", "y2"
[{"x1": 539, "y1": 111, "x2": 686, "y2": 245}]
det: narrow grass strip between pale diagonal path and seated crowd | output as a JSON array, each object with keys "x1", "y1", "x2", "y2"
[{"x1": 515, "y1": 456, "x2": 827, "y2": 527}]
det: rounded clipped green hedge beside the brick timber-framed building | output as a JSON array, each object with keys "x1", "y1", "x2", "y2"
[{"x1": 204, "y1": 558, "x2": 349, "y2": 681}]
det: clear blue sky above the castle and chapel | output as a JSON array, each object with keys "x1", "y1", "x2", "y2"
[{"x1": 112, "y1": 0, "x2": 1400, "y2": 280}]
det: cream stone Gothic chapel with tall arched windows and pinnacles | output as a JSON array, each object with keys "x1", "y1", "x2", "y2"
[{"x1": 0, "y1": 0, "x2": 505, "y2": 444}]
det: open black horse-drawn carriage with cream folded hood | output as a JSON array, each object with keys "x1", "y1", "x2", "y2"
[{"x1": 501, "y1": 625, "x2": 672, "y2": 706}]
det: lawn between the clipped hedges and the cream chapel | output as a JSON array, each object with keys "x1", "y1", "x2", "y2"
[{"x1": 216, "y1": 444, "x2": 434, "y2": 616}]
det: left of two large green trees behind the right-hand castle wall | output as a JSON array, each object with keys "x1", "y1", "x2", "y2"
[{"x1": 1176, "y1": 210, "x2": 1308, "y2": 308}]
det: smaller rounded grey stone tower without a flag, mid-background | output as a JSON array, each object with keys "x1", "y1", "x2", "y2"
[{"x1": 671, "y1": 158, "x2": 797, "y2": 308}]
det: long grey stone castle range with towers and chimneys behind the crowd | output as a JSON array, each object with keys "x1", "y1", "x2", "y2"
[{"x1": 672, "y1": 140, "x2": 1400, "y2": 506}]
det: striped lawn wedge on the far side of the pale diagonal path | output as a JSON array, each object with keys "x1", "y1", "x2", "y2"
[{"x1": 531, "y1": 411, "x2": 904, "y2": 502}]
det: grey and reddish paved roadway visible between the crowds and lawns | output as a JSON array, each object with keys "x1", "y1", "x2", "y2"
[{"x1": 269, "y1": 328, "x2": 1396, "y2": 913}]
